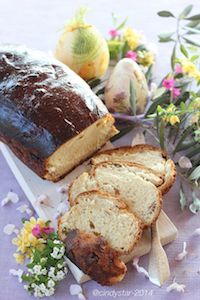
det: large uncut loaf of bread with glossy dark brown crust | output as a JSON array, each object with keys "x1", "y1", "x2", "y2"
[{"x1": 0, "y1": 45, "x2": 117, "y2": 181}]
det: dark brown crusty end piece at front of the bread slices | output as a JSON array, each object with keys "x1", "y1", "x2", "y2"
[{"x1": 65, "y1": 230, "x2": 127, "y2": 285}]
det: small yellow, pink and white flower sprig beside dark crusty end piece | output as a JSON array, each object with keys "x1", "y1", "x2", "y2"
[{"x1": 13, "y1": 217, "x2": 67, "y2": 298}]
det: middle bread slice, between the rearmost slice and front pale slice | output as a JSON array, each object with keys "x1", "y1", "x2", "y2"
[{"x1": 69, "y1": 162, "x2": 162, "y2": 226}]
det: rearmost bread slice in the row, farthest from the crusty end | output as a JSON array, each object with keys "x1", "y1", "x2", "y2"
[{"x1": 91, "y1": 144, "x2": 176, "y2": 194}]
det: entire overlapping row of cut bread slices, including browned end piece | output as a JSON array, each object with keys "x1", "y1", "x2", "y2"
[{"x1": 59, "y1": 145, "x2": 176, "y2": 285}]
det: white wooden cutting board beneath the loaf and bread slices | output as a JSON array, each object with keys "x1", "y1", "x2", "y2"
[{"x1": 0, "y1": 142, "x2": 177, "y2": 283}]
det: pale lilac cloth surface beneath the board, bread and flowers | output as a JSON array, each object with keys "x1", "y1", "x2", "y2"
[{"x1": 0, "y1": 0, "x2": 200, "y2": 300}]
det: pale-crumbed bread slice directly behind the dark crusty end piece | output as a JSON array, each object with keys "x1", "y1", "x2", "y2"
[{"x1": 58, "y1": 191, "x2": 142, "y2": 254}]
